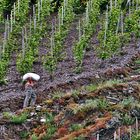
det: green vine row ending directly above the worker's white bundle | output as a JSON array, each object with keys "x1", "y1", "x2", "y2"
[{"x1": 17, "y1": 1, "x2": 52, "y2": 74}]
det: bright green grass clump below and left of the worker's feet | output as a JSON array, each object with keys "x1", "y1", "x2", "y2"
[{"x1": 11, "y1": 113, "x2": 28, "y2": 124}]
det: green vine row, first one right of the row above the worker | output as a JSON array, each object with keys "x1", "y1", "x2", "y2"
[{"x1": 43, "y1": 0, "x2": 75, "y2": 76}]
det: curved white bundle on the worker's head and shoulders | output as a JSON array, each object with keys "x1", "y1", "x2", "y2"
[{"x1": 22, "y1": 73, "x2": 40, "y2": 81}]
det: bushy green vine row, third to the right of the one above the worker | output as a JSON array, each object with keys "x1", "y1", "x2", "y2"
[{"x1": 97, "y1": 6, "x2": 121, "y2": 59}]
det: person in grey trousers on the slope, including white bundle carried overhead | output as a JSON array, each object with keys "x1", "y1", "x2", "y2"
[{"x1": 23, "y1": 73, "x2": 40, "y2": 108}]
